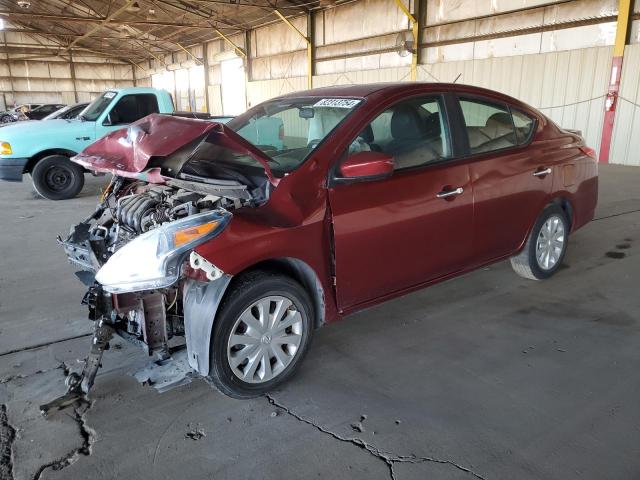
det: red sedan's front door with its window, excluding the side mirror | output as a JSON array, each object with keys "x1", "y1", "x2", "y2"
[{"x1": 329, "y1": 95, "x2": 473, "y2": 311}]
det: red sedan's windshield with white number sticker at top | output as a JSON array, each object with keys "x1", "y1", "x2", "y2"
[{"x1": 227, "y1": 97, "x2": 362, "y2": 176}]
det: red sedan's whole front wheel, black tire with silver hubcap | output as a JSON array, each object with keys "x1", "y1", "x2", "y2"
[{"x1": 209, "y1": 271, "x2": 314, "y2": 399}]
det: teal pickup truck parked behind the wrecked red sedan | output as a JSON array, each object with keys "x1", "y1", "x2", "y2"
[{"x1": 0, "y1": 87, "x2": 174, "y2": 200}]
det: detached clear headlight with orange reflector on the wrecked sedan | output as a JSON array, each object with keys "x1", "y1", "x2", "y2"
[{"x1": 96, "y1": 210, "x2": 231, "y2": 293}]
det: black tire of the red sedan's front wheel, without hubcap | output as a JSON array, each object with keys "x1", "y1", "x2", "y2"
[{"x1": 208, "y1": 271, "x2": 314, "y2": 399}]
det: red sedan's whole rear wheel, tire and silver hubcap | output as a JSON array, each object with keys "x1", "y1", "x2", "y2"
[{"x1": 511, "y1": 205, "x2": 569, "y2": 280}]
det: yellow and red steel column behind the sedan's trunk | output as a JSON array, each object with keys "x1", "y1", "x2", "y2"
[{"x1": 598, "y1": 0, "x2": 631, "y2": 163}]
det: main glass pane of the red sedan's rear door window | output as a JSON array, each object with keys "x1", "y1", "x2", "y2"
[{"x1": 460, "y1": 98, "x2": 518, "y2": 153}]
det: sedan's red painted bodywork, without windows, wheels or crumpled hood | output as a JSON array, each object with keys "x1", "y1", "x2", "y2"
[{"x1": 77, "y1": 83, "x2": 598, "y2": 321}]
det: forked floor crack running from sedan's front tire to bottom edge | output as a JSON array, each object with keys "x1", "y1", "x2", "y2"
[{"x1": 265, "y1": 394, "x2": 486, "y2": 480}]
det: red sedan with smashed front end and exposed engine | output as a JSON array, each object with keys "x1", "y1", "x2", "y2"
[{"x1": 44, "y1": 83, "x2": 598, "y2": 409}]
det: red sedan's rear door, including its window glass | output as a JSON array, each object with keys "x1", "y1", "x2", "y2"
[{"x1": 459, "y1": 97, "x2": 553, "y2": 264}]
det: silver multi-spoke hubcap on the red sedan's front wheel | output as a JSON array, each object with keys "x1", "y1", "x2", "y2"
[{"x1": 227, "y1": 296, "x2": 304, "y2": 383}]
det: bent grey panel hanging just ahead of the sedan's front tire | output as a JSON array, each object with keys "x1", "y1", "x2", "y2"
[{"x1": 182, "y1": 274, "x2": 233, "y2": 376}]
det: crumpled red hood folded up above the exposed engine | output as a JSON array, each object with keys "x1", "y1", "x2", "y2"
[{"x1": 71, "y1": 114, "x2": 277, "y2": 185}]
